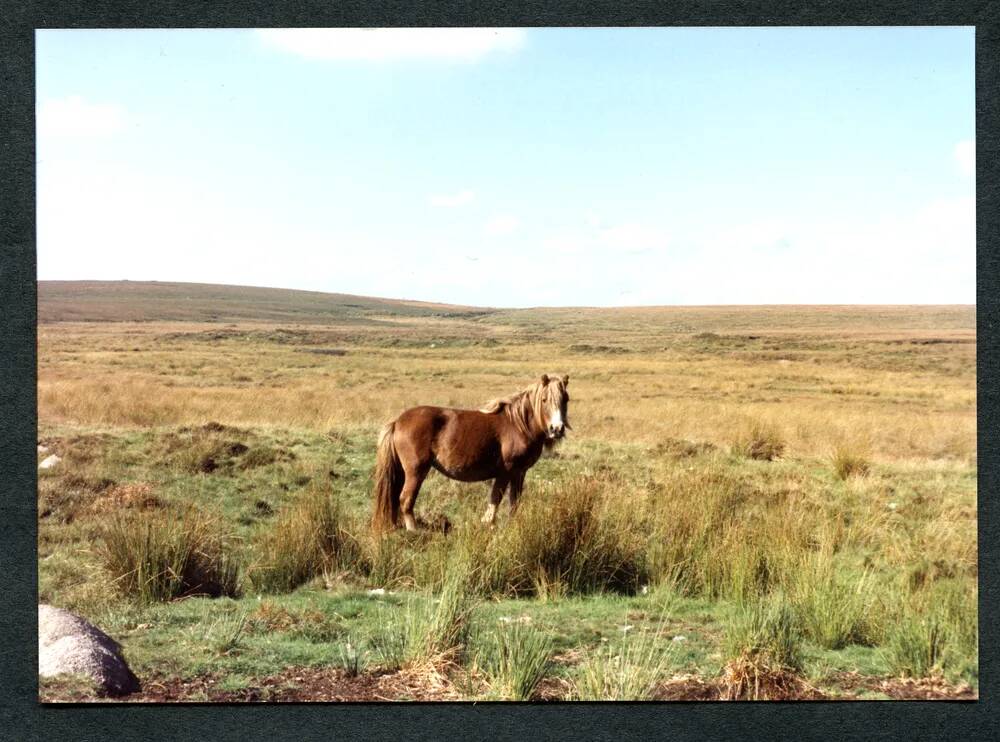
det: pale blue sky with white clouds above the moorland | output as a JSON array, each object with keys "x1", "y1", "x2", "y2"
[{"x1": 37, "y1": 28, "x2": 975, "y2": 306}]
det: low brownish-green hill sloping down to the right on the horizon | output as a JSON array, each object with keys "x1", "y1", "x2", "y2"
[{"x1": 38, "y1": 281, "x2": 489, "y2": 324}]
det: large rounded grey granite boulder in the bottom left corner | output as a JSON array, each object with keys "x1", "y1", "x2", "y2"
[{"x1": 38, "y1": 605, "x2": 140, "y2": 696}]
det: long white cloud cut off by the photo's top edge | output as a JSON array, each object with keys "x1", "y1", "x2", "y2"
[{"x1": 257, "y1": 28, "x2": 525, "y2": 62}]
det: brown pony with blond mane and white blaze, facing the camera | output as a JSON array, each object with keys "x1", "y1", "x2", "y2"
[{"x1": 372, "y1": 374, "x2": 569, "y2": 532}]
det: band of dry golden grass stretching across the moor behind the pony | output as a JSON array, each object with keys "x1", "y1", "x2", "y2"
[{"x1": 38, "y1": 308, "x2": 976, "y2": 462}]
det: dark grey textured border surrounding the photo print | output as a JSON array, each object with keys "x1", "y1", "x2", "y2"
[{"x1": 0, "y1": 0, "x2": 1000, "y2": 740}]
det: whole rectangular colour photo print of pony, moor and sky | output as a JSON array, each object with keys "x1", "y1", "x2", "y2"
[{"x1": 35, "y1": 26, "x2": 979, "y2": 703}]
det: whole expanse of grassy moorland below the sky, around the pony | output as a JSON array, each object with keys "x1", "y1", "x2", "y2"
[{"x1": 38, "y1": 282, "x2": 978, "y2": 701}]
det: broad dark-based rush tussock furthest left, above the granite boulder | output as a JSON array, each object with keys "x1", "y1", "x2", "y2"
[{"x1": 102, "y1": 509, "x2": 240, "y2": 602}]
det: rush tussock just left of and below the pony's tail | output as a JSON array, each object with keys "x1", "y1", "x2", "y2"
[{"x1": 249, "y1": 490, "x2": 360, "y2": 592}]
